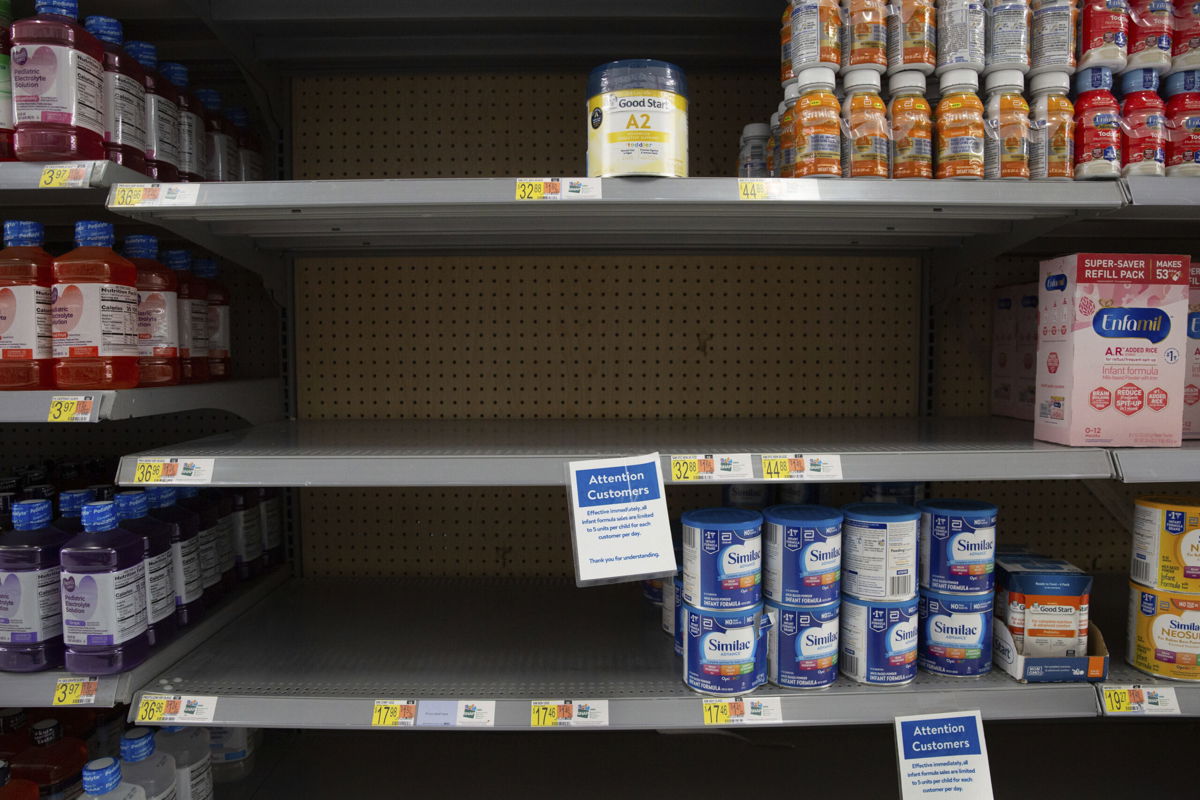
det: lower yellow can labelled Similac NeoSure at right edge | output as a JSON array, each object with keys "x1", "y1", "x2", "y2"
[{"x1": 1126, "y1": 581, "x2": 1200, "y2": 680}]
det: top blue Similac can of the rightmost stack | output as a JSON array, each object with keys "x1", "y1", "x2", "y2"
[{"x1": 917, "y1": 500, "x2": 997, "y2": 594}]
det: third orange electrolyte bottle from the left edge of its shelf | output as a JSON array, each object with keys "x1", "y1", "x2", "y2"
[{"x1": 125, "y1": 234, "x2": 180, "y2": 386}]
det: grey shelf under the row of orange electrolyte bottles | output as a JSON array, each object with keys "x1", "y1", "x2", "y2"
[{"x1": 0, "y1": 378, "x2": 283, "y2": 425}]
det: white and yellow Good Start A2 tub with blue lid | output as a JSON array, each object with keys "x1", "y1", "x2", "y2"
[{"x1": 588, "y1": 59, "x2": 688, "y2": 178}]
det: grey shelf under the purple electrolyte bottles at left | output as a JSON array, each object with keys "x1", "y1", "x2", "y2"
[{"x1": 0, "y1": 569, "x2": 288, "y2": 708}]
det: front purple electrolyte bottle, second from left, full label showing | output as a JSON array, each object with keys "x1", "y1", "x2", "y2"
[{"x1": 61, "y1": 501, "x2": 150, "y2": 675}]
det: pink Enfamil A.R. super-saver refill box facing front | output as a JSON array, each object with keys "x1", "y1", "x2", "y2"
[{"x1": 1033, "y1": 253, "x2": 1192, "y2": 447}]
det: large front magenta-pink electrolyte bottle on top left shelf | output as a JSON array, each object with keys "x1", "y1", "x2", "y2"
[{"x1": 11, "y1": 0, "x2": 106, "y2": 161}]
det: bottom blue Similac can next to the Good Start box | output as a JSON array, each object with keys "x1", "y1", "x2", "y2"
[{"x1": 917, "y1": 589, "x2": 994, "y2": 678}]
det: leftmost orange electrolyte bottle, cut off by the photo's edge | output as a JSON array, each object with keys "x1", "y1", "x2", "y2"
[{"x1": 0, "y1": 219, "x2": 54, "y2": 390}]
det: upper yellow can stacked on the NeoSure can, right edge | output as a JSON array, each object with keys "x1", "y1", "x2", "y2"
[{"x1": 1129, "y1": 497, "x2": 1200, "y2": 594}]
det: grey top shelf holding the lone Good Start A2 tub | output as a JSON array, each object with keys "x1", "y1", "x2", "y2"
[{"x1": 100, "y1": 178, "x2": 1126, "y2": 254}]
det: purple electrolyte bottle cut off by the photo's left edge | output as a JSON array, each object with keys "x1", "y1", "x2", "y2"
[{"x1": 0, "y1": 500, "x2": 70, "y2": 672}]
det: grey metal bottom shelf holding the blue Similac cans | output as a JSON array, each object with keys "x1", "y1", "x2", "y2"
[{"x1": 129, "y1": 578, "x2": 1098, "y2": 729}]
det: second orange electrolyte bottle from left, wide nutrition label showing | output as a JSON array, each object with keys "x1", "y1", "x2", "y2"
[{"x1": 50, "y1": 221, "x2": 138, "y2": 389}]
